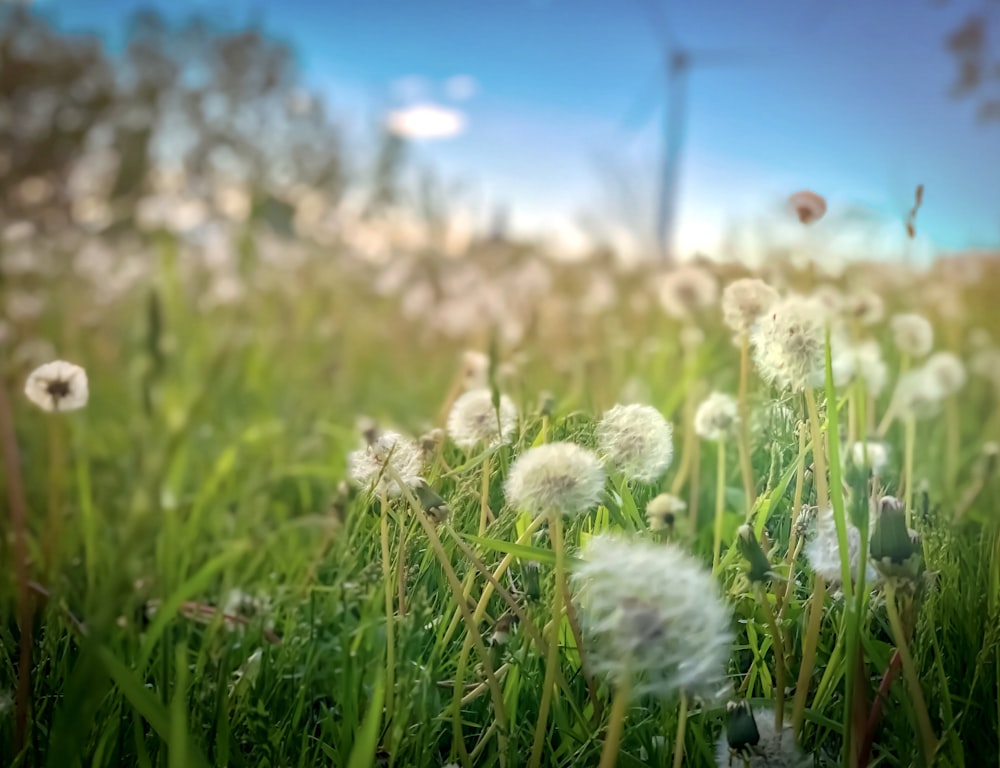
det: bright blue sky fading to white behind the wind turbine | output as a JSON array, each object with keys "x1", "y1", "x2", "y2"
[{"x1": 38, "y1": 0, "x2": 1000, "y2": 258}]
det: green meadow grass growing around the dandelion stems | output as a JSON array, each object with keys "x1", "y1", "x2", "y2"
[{"x1": 0, "y1": 241, "x2": 1000, "y2": 768}]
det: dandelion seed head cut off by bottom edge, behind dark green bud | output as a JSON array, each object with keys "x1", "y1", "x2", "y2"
[{"x1": 715, "y1": 702, "x2": 812, "y2": 768}]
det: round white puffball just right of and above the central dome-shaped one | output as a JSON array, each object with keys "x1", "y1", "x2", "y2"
[{"x1": 597, "y1": 404, "x2": 674, "y2": 483}]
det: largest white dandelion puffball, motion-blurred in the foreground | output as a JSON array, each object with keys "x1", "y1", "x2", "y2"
[{"x1": 571, "y1": 534, "x2": 732, "y2": 698}]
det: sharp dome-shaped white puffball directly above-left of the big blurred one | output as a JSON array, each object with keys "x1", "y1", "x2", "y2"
[{"x1": 504, "y1": 443, "x2": 604, "y2": 517}]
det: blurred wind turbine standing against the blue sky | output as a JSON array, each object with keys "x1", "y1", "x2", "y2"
[{"x1": 630, "y1": 0, "x2": 745, "y2": 262}]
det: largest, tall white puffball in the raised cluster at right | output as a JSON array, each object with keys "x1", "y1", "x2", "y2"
[{"x1": 751, "y1": 296, "x2": 826, "y2": 392}]
